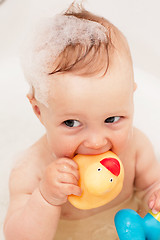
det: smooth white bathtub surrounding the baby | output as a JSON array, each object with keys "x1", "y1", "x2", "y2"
[{"x1": 0, "y1": 0, "x2": 160, "y2": 239}]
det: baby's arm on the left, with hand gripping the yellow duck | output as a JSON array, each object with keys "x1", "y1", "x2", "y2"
[{"x1": 4, "y1": 155, "x2": 80, "y2": 240}]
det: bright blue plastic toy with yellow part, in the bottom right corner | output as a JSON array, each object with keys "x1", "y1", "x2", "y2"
[{"x1": 114, "y1": 209, "x2": 160, "y2": 240}]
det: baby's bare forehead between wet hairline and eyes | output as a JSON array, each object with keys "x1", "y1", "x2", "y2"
[{"x1": 46, "y1": 70, "x2": 133, "y2": 121}]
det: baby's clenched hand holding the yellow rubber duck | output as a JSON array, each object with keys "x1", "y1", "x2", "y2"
[{"x1": 39, "y1": 158, "x2": 81, "y2": 205}]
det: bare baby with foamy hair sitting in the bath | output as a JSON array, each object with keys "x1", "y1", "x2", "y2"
[{"x1": 4, "y1": 1, "x2": 160, "y2": 240}]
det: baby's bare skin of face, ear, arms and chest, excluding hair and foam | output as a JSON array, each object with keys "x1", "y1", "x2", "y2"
[{"x1": 4, "y1": 50, "x2": 160, "y2": 240}]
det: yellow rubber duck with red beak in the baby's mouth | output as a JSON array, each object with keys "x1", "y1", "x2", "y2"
[{"x1": 68, "y1": 151, "x2": 124, "y2": 209}]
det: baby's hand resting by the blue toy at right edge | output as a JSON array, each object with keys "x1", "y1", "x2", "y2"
[{"x1": 148, "y1": 189, "x2": 160, "y2": 214}]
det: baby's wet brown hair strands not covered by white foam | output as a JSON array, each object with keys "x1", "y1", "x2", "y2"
[{"x1": 50, "y1": 4, "x2": 111, "y2": 76}]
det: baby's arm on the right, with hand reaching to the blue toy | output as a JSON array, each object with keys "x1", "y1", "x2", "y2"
[{"x1": 135, "y1": 130, "x2": 160, "y2": 213}]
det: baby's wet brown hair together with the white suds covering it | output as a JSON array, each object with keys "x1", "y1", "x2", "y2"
[{"x1": 22, "y1": 0, "x2": 131, "y2": 106}]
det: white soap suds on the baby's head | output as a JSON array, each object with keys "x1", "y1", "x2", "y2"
[{"x1": 22, "y1": 15, "x2": 108, "y2": 106}]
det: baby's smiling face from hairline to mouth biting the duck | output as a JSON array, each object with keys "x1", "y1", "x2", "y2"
[{"x1": 38, "y1": 52, "x2": 134, "y2": 158}]
